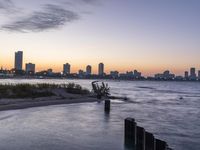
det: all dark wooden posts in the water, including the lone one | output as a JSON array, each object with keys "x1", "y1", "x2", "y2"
[{"x1": 104, "y1": 100, "x2": 170, "y2": 150}]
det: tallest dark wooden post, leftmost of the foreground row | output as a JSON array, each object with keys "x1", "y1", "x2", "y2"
[{"x1": 124, "y1": 118, "x2": 137, "y2": 149}]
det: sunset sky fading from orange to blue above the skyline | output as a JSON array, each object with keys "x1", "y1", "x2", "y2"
[{"x1": 0, "y1": 0, "x2": 200, "y2": 76}]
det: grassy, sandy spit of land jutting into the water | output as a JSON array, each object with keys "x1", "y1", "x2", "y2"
[{"x1": 0, "y1": 83, "x2": 99, "y2": 111}]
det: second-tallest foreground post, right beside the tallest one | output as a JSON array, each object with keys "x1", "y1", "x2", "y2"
[{"x1": 137, "y1": 126, "x2": 145, "y2": 150}]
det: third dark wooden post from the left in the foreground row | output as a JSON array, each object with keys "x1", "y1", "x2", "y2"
[{"x1": 145, "y1": 132, "x2": 156, "y2": 150}]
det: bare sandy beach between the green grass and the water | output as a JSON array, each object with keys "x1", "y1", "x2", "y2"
[{"x1": 0, "y1": 89, "x2": 98, "y2": 111}]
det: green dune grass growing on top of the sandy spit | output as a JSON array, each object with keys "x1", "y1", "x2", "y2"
[{"x1": 0, "y1": 83, "x2": 90, "y2": 98}]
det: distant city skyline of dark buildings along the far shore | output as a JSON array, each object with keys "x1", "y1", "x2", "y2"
[{"x1": 1, "y1": 51, "x2": 200, "y2": 80}]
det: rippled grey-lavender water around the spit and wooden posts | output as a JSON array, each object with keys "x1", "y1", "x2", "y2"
[{"x1": 0, "y1": 80, "x2": 200, "y2": 150}]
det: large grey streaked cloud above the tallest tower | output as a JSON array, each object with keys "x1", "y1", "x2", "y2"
[{"x1": 2, "y1": 4, "x2": 79, "y2": 32}]
